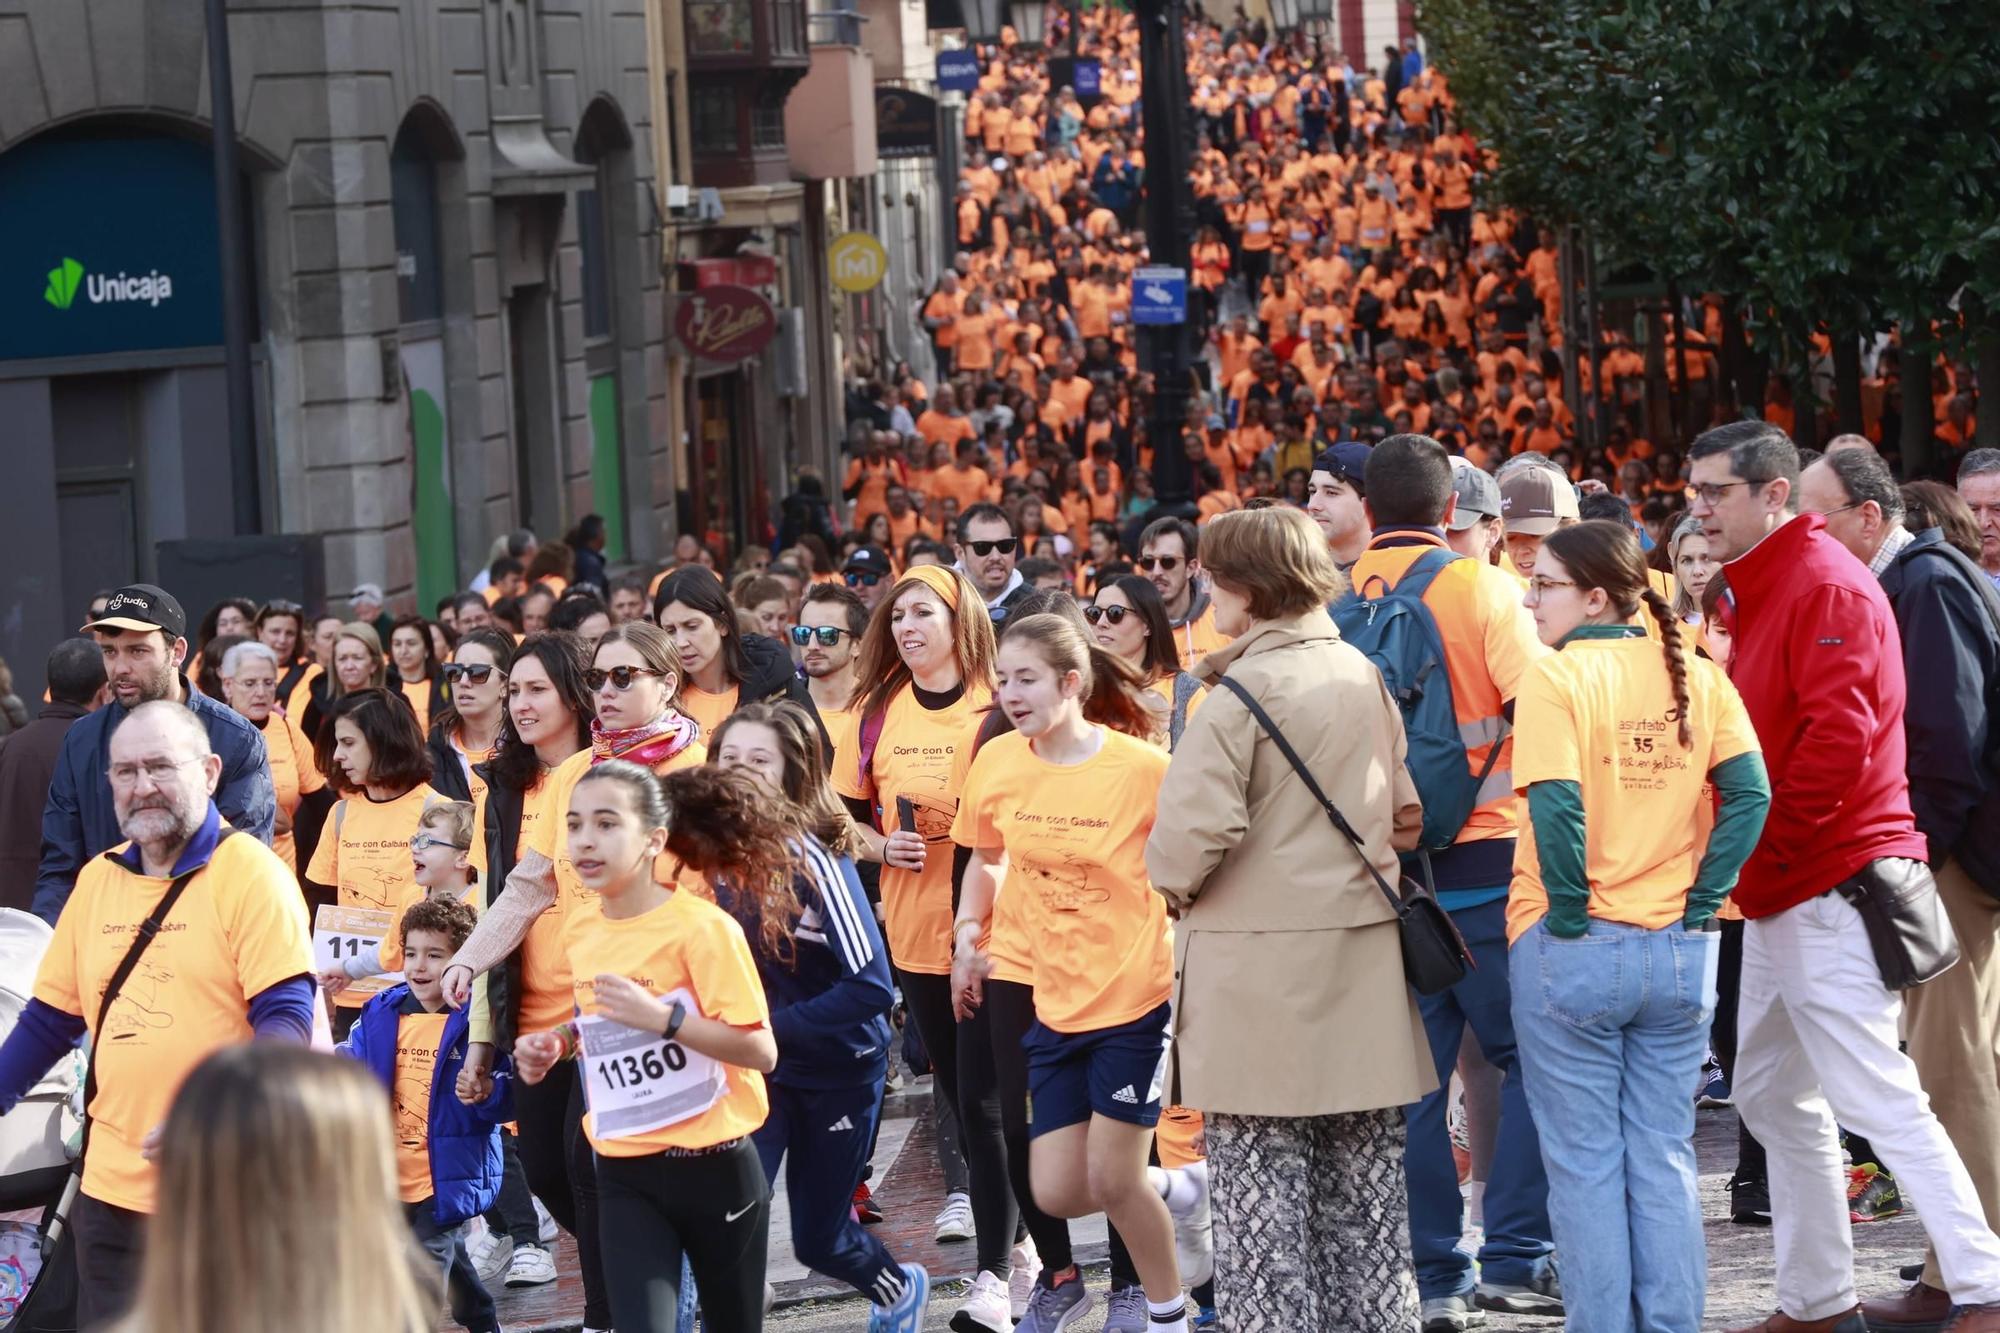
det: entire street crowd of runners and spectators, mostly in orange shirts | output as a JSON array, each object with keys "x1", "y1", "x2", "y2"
[{"x1": 0, "y1": 8, "x2": 2000, "y2": 1333}]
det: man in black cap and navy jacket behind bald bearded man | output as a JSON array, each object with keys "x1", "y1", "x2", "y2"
[{"x1": 34, "y1": 582, "x2": 278, "y2": 925}]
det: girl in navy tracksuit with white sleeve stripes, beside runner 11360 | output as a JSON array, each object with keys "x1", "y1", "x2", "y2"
[{"x1": 696, "y1": 716, "x2": 930, "y2": 1333}]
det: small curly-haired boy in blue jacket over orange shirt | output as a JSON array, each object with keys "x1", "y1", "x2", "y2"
[{"x1": 338, "y1": 899, "x2": 514, "y2": 1333}]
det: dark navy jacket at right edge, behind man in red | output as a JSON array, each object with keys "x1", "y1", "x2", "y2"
[{"x1": 1882, "y1": 528, "x2": 2000, "y2": 897}]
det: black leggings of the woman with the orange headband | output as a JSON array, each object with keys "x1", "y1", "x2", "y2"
[{"x1": 898, "y1": 960, "x2": 1020, "y2": 1277}]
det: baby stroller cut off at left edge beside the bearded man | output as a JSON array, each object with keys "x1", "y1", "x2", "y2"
[{"x1": 0, "y1": 909, "x2": 84, "y2": 1333}]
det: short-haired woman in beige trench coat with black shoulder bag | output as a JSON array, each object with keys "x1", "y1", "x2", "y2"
[{"x1": 1146, "y1": 508, "x2": 1436, "y2": 1333}]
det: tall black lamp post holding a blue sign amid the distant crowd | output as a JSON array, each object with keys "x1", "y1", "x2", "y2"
[{"x1": 1134, "y1": 0, "x2": 1194, "y2": 516}]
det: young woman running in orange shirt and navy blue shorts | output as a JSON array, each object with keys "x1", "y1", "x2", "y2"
[{"x1": 952, "y1": 614, "x2": 1188, "y2": 1333}]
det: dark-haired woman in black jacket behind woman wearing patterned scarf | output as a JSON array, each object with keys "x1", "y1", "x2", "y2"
[{"x1": 652, "y1": 568, "x2": 832, "y2": 753}]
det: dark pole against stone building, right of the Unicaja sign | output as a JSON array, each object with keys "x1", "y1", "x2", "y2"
[{"x1": 206, "y1": 0, "x2": 264, "y2": 536}]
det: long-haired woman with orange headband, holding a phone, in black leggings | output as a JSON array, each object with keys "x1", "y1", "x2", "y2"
[{"x1": 834, "y1": 564, "x2": 1028, "y2": 1333}]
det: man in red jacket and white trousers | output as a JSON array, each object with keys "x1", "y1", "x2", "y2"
[{"x1": 1688, "y1": 422, "x2": 2000, "y2": 1333}]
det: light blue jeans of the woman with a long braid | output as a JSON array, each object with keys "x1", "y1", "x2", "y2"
[{"x1": 1512, "y1": 921, "x2": 1722, "y2": 1333}]
